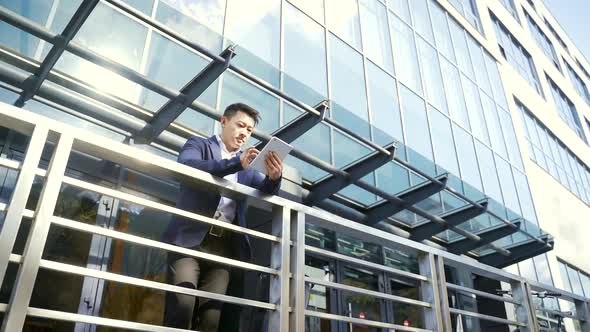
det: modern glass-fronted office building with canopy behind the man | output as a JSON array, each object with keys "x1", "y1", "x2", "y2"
[{"x1": 0, "y1": 0, "x2": 590, "y2": 331}]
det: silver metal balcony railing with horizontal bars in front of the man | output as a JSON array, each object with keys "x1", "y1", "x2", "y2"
[{"x1": 0, "y1": 104, "x2": 590, "y2": 332}]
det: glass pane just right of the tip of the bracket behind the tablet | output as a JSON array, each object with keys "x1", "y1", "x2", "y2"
[{"x1": 330, "y1": 35, "x2": 369, "y2": 137}]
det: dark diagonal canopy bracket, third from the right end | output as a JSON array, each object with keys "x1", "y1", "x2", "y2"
[{"x1": 410, "y1": 199, "x2": 488, "y2": 242}]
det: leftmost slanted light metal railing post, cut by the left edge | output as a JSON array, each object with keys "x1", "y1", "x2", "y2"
[{"x1": 0, "y1": 125, "x2": 49, "y2": 287}]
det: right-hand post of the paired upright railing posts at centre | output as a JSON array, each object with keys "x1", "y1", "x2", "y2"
[{"x1": 289, "y1": 211, "x2": 309, "y2": 332}]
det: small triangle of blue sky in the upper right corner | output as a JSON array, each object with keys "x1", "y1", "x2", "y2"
[{"x1": 543, "y1": 0, "x2": 590, "y2": 62}]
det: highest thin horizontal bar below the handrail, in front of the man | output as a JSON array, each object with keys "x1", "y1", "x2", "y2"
[{"x1": 63, "y1": 176, "x2": 281, "y2": 242}]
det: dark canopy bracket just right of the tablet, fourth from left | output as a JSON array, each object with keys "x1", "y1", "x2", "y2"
[{"x1": 305, "y1": 143, "x2": 396, "y2": 205}]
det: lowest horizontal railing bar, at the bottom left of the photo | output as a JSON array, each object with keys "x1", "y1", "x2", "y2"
[{"x1": 0, "y1": 303, "x2": 190, "y2": 332}]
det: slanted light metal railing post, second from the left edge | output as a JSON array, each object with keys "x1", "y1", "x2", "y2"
[{"x1": 0, "y1": 134, "x2": 74, "y2": 332}]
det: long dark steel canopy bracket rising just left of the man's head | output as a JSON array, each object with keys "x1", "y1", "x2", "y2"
[{"x1": 134, "y1": 45, "x2": 236, "y2": 144}]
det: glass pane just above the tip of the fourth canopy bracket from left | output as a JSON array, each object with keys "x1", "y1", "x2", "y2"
[{"x1": 367, "y1": 62, "x2": 403, "y2": 145}]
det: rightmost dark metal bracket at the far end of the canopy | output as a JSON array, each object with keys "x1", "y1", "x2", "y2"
[{"x1": 478, "y1": 235, "x2": 554, "y2": 269}]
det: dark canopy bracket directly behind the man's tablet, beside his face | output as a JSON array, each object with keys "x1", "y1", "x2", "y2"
[{"x1": 256, "y1": 100, "x2": 329, "y2": 150}]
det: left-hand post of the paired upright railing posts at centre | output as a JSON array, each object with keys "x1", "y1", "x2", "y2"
[{"x1": 268, "y1": 206, "x2": 291, "y2": 332}]
